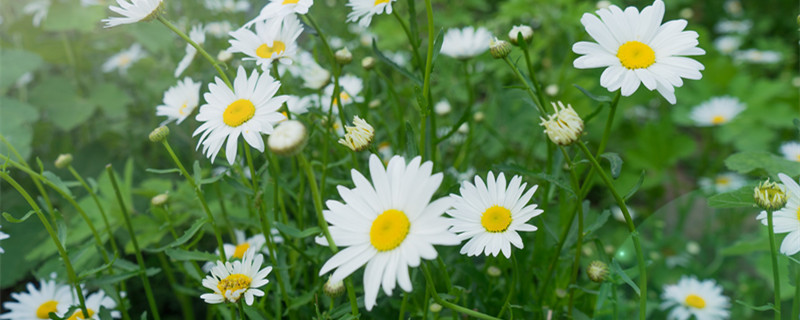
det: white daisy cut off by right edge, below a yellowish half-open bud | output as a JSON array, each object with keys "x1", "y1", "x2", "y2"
[{"x1": 756, "y1": 173, "x2": 800, "y2": 256}]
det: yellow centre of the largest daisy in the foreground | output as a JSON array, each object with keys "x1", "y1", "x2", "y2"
[{"x1": 369, "y1": 209, "x2": 411, "y2": 251}]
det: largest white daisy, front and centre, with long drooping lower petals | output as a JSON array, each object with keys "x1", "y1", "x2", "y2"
[{"x1": 316, "y1": 154, "x2": 459, "y2": 310}]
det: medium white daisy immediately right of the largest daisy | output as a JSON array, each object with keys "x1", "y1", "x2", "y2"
[{"x1": 447, "y1": 171, "x2": 543, "y2": 258}]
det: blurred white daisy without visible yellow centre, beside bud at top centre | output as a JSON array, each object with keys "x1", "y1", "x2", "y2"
[{"x1": 442, "y1": 27, "x2": 492, "y2": 60}]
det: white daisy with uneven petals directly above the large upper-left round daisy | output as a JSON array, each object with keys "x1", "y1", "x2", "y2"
[{"x1": 233, "y1": 15, "x2": 303, "y2": 70}]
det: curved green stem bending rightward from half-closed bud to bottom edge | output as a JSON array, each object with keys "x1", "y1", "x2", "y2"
[{"x1": 577, "y1": 140, "x2": 647, "y2": 320}]
